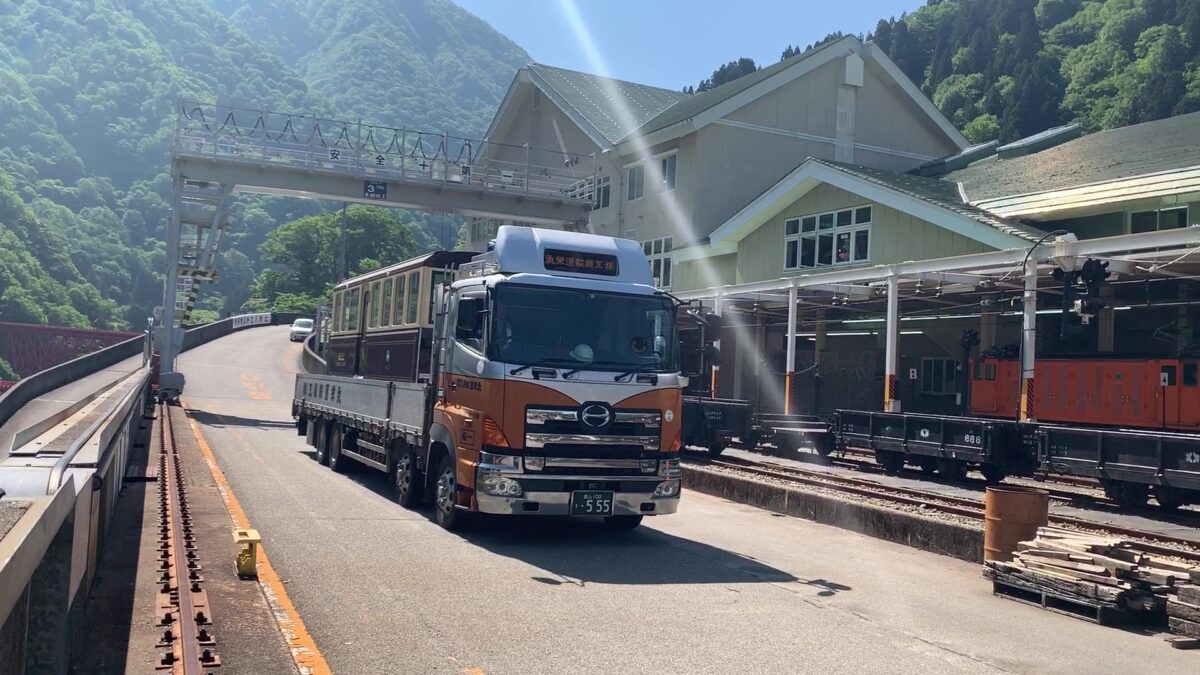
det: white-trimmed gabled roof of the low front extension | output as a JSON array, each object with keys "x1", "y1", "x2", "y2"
[{"x1": 680, "y1": 157, "x2": 1043, "y2": 260}]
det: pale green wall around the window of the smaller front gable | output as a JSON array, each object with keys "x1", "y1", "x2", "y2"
[{"x1": 729, "y1": 184, "x2": 991, "y2": 283}]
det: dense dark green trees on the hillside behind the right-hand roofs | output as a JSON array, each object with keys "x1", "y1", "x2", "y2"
[{"x1": 872, "y1": 0, "x2": 1200, "y2": 142}]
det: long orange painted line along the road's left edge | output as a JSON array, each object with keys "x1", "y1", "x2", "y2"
[{"x1": 180, "y1": 404, "x2": 332, "y2": 675}]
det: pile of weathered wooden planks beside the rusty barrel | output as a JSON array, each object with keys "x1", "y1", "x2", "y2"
[{"x1": 984, "y1": 527, "x2": 1200, "y2": 634}]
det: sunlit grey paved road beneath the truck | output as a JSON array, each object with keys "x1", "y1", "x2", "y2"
[{"x1": 181, "y1": 328, "x2": 1196, "y2": 674}]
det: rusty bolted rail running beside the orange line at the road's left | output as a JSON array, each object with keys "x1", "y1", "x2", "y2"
[{"x1": 155, "y1": 404, "x2": 221, "y2": 675}]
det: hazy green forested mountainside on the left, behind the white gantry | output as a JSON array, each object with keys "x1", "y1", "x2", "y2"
[{"x1": 0, "y1": 0, "x2": 527, "y2": 336}]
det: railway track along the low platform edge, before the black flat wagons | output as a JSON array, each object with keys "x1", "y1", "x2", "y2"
[{"x1": 697, "y1": 458, "x2": 1200, "y2": 563}]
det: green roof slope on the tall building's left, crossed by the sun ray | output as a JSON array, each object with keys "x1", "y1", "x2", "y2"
[{"x1": 528, "y1": 64, "x2": 690, "y2": 143}]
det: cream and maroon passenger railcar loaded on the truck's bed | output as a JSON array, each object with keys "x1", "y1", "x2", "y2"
[{"x1": 326, "y1": 251, "x2": 475, "y2": 382}]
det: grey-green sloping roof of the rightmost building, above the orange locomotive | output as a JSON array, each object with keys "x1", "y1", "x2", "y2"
[{"x1": 946, "y1": 113, "x2": 1200, "y2": 202}]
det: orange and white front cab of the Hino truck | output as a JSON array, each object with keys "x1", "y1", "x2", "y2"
[{"x1": 427, "y1": 227, "x2": 684, "y2": 527}]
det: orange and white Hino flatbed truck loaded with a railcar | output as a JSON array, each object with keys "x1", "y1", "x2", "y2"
[{"x1": 292, "y1": 227, "x2": 686, "y2": 530}]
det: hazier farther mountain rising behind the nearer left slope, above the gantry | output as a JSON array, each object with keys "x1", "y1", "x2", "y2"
[{"x1": 212, "y1": 0, "x2": 529, "y2": 138}]
